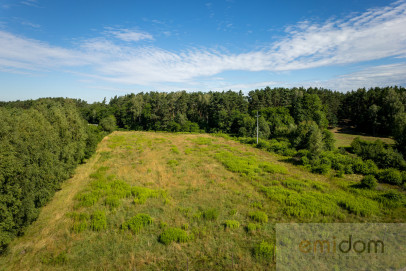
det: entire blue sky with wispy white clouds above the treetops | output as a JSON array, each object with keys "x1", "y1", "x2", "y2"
[{"x1": 0, "y1": 0, "x2": 406, "y2": 102}]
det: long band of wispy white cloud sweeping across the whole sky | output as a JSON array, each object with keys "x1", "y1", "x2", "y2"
[{"x1": 0, "y1": 1, "x2": 406, "y2": 89}]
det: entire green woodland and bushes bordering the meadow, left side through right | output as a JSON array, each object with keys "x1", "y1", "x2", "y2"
[{"x1": 0, "y1": 87, "x2": 406, "y2": 254}]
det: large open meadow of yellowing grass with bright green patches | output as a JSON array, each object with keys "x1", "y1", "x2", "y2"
[{"x1": 0, "y1": 132, "x2": 406, "y2": 270}]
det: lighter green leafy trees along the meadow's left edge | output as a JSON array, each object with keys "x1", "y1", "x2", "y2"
[{"x1": 0, "y1": 99, "x2": 104, "y2": 252}]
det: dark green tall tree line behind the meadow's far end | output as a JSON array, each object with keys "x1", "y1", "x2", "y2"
[{"x1": 78, "y1": 86, "x2": 406, "y2": 153}]
